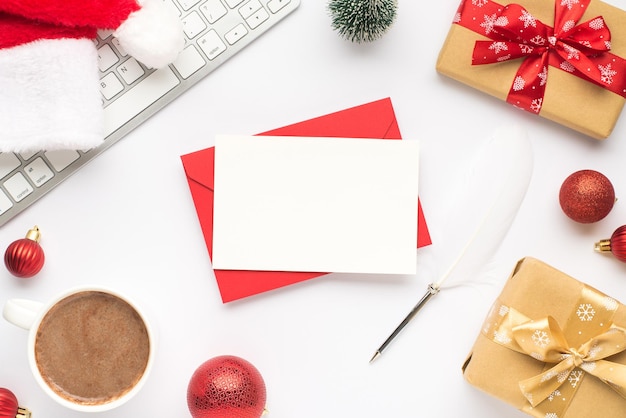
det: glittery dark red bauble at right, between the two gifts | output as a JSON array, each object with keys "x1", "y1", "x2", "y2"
[{"x1": 559, "y1": 170, "x2": 615, "y2": 224}]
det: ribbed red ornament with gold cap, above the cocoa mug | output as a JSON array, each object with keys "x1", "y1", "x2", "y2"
[{"x1": 4, "y1": 226, "x2": 45, "y2": 278}]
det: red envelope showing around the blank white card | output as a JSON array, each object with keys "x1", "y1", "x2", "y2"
[{"x1": 181, "y1": 98, "x2": 431, "y2": 303}]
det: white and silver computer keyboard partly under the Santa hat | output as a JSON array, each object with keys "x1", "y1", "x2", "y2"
[{"x1": 0, "y1": 0, "x2": 300, "y2": 226}]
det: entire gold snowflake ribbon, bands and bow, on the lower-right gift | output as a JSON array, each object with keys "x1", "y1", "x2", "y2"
[{"x1": 483, "y1": 286, "x2": 626, "y2": 417}]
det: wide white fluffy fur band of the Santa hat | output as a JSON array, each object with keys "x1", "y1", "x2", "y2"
[{"x1": 0, "y1": 39, "x2": 104, "y2": 152}]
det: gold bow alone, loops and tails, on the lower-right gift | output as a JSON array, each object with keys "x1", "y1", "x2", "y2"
[{"x1": 512, "y1": 317, "x2": 626, "y2": 406}]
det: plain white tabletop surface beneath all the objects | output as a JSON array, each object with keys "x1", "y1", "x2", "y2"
[{"x1": 0, "y1": 0, "x2": 626, "y2": 418}]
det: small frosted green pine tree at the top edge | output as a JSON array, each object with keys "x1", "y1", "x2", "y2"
[{"x1": 328, "y1": 0, "x2": 398, "y2": 43}]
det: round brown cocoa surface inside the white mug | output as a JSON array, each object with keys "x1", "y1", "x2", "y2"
[{"x1": 35, "y1": 291, "x2": 150, "y2": 405}]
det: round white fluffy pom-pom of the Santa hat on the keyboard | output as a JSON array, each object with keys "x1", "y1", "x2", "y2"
[{"x1": 113, "y1": 0, "x2": 185, "y2": 68}]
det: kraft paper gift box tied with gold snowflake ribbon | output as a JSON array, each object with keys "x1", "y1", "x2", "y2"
[{"x1": 463, "y1": 258, "x2": 626, "y2": 418}]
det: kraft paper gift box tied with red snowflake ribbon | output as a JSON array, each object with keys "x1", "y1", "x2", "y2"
[{"x1": 436, "y1": 0, "x2": 626, "y2": 139}]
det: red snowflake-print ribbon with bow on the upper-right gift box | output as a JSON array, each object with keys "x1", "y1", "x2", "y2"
[{"x1": 466, "y1": 0, "x2": 626, "y2": 113}]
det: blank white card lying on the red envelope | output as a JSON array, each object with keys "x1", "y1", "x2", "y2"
[{"x1": 212, "y1": 135, "x2": 419, "y2": 274}]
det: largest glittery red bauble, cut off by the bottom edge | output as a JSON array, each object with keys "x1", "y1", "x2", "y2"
[{"x1": 187, "y1": 356, "x2": 266, "y2": 418}]
